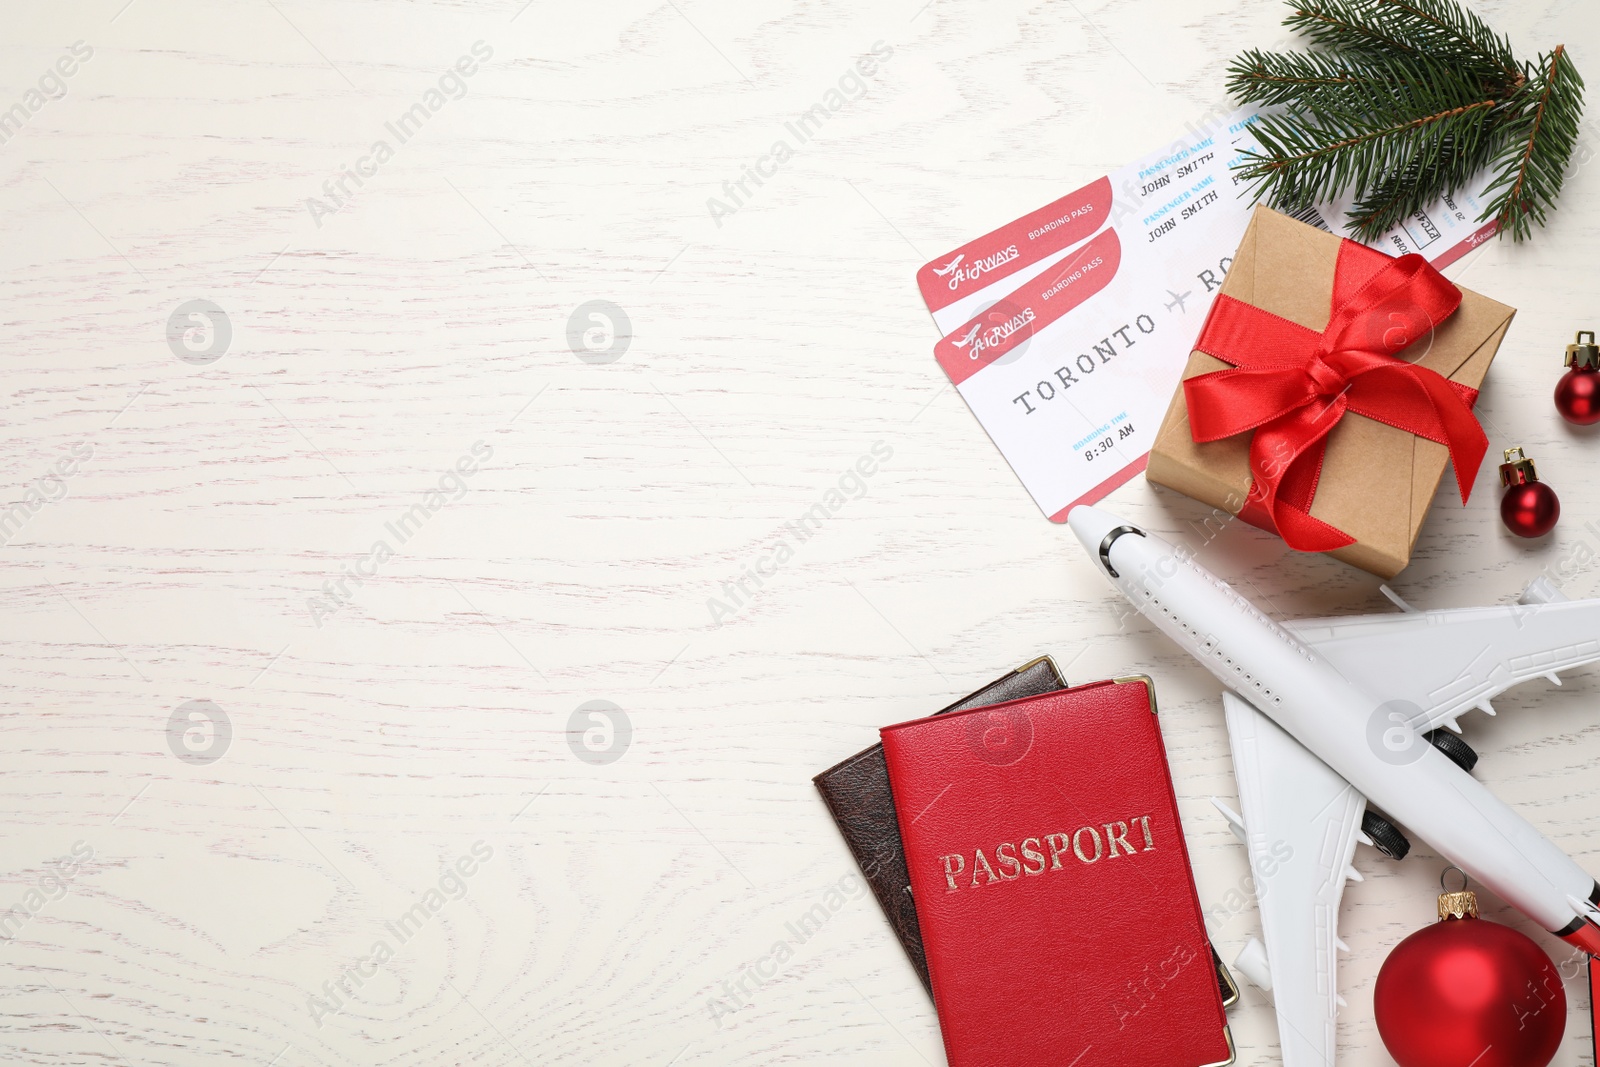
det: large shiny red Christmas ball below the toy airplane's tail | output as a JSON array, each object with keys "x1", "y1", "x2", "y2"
[{"x1": 1373, "y1": 891, "x2": 1566, "y2": 1067}]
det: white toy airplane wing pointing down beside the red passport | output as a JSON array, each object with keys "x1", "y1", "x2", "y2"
[{"x1": 1213, "y1": 693, "x2": 1366, "y2": 1067}]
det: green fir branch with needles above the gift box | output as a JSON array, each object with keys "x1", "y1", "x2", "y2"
[{"x1": 1227, "y1": 0, "x2": 1582, "y2": 240}]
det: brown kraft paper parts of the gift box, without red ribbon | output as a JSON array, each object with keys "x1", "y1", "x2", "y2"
[{"x1": 1146, "y1": 206, "x2": 1515, "y2": 577}]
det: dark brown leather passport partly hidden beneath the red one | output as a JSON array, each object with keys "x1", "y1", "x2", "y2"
[{"x1": 811, "y1": 656, "x2": 1067, "y2": 995}]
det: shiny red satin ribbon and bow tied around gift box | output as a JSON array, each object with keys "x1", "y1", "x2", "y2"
[{"x1": 1184, "y1": 240, "x2": 1488, "y2": 552}]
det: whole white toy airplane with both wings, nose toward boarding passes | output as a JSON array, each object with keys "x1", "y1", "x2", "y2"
[{"x1": 1067, "y1": 507, "x2": 1600, "y2": 1067}]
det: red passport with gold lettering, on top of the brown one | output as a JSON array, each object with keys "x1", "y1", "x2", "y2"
[{"x1": 882, "y1": 678, "x2": 1234, "y2": 1067}]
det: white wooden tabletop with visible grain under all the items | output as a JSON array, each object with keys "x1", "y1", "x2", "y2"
[{"x1": 0, "y1": 0, "x2": 1600, "y2": 1067}]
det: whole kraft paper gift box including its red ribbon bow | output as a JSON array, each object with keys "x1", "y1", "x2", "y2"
[{"x1": 1146, "y1": 208, "x2": 1515, "y2": 577}]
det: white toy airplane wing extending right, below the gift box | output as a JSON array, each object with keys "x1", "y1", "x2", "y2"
[{"x1": 1286, "y1": 577, "x2": 1600, "y2": 733}]
